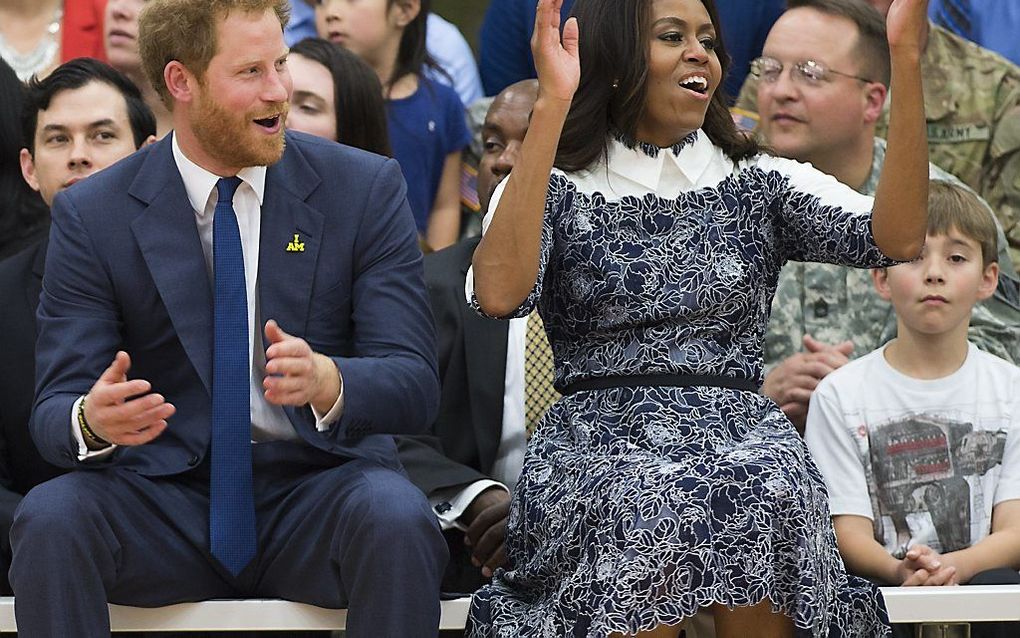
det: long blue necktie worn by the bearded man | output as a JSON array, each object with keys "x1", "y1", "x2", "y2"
[{"x1": 209, "y1": 178, "x2": 257, "y2": 576}]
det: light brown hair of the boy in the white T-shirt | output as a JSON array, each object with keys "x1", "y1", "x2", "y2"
[{"x1": 928, "y1": 180, "x2": 999, "y2": 266}]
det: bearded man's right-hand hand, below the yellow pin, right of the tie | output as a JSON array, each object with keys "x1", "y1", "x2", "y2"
[{"x1": 262, "y1": 320, "x2": 340, "y2": 414}]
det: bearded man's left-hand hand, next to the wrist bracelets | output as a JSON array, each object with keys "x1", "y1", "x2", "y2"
[{"x1": 85, "y1": 350, "x2": 176, "y2": 445}]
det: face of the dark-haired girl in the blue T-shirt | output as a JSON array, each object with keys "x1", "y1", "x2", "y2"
[{"x1": 313, "y1": 0, "x2": 410, "y2": 68}]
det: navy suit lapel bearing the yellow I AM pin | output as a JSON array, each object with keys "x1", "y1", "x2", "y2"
[{"x1": 258, "y1": 139, "x2": 324, "y2": 347}]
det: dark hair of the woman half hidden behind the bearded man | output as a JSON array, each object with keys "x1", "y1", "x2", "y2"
[{"x1": 291, "y1": 38, "x2": 393, "y2": 156}]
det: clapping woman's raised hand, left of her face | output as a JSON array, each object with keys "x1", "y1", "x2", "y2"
[{"x1": 531, "y1": 0, "x2": 580, "y2": 102}]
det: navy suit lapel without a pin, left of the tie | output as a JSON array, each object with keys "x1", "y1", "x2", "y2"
[{"x1": 130, "y1": 136, "x2": 212, "y2": 390}]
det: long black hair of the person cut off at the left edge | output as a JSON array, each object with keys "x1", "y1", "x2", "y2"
[{"x1": 0, "y1": 58, "x2": 49, "y2": 255}]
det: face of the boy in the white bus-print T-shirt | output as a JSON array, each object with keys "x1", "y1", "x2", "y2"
[{"x1": 872, "y1": 229, "x2": 999, "y2": 338}]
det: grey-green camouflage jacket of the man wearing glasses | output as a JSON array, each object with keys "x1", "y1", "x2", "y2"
[{"x1": 765, "y1": 138, "x2": 1020, "y2": 370}]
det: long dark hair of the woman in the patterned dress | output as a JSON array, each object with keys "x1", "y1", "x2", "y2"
[{"x1": 556, "y1": 0, "x2": 760, "y2": 171}]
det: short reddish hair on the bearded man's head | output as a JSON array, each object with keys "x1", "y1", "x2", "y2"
[{"x1": 138, "y1": 0, "x2": 291, "y2": 108}]
